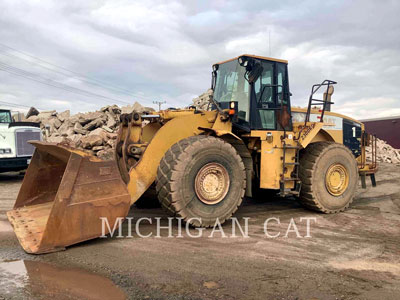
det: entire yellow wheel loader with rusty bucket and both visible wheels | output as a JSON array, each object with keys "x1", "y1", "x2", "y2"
[{"x1": 8, "y1": 55, "x2": 377, "y2": 253}]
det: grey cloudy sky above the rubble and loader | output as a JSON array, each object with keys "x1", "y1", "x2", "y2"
[{"x1": 0, "y1": 0, "x2": 400, "y2": 118}]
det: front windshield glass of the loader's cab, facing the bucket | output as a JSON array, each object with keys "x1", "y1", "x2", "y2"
[{"x1": 214, "y1": 60, "x2": 250, "y2": 122}]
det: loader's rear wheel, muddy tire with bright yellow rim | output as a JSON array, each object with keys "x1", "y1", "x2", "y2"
[{"x1": 299, "y1": 142, "x2": 358, "y2": 213}]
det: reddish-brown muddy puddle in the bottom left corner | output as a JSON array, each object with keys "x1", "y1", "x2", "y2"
[{"x1": 0, "y1": 260, "x2": 126, "y2": 300}]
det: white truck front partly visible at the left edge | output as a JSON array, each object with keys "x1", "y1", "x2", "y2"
[{"x1": 0, "y1": 109, "x2": 42, "y2": 172}]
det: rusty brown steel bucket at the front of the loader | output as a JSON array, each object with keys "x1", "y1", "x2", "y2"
[{"x1": 7, "y1": 142, "x2": 130, "y2": 254}]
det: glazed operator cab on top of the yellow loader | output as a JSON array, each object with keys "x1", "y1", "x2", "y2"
[{"x1": 212, "y1": 54, "x2": 292, "y2": 132}]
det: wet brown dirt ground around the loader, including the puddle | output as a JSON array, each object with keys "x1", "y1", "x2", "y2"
[{"x1": 0, "y1": 164, "x2": 400, "y2": 299}]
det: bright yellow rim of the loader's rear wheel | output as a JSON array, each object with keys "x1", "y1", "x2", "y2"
[{"x1": 325, "y1": 163, "x2": 349, "y2": 196}]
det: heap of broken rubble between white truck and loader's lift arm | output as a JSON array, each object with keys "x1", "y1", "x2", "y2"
[{"x1": 26, "y1": 102, "x2": 153, "y2": 160}]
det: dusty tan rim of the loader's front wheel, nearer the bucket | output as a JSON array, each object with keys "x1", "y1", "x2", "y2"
[{"x1": 194, "y1": 162, "x2": 230, "y2": 205}]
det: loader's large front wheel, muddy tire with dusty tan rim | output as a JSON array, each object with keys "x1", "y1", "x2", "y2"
[{"x1": 156, "y1": 135, "x2": 246, "y2": 227}]
